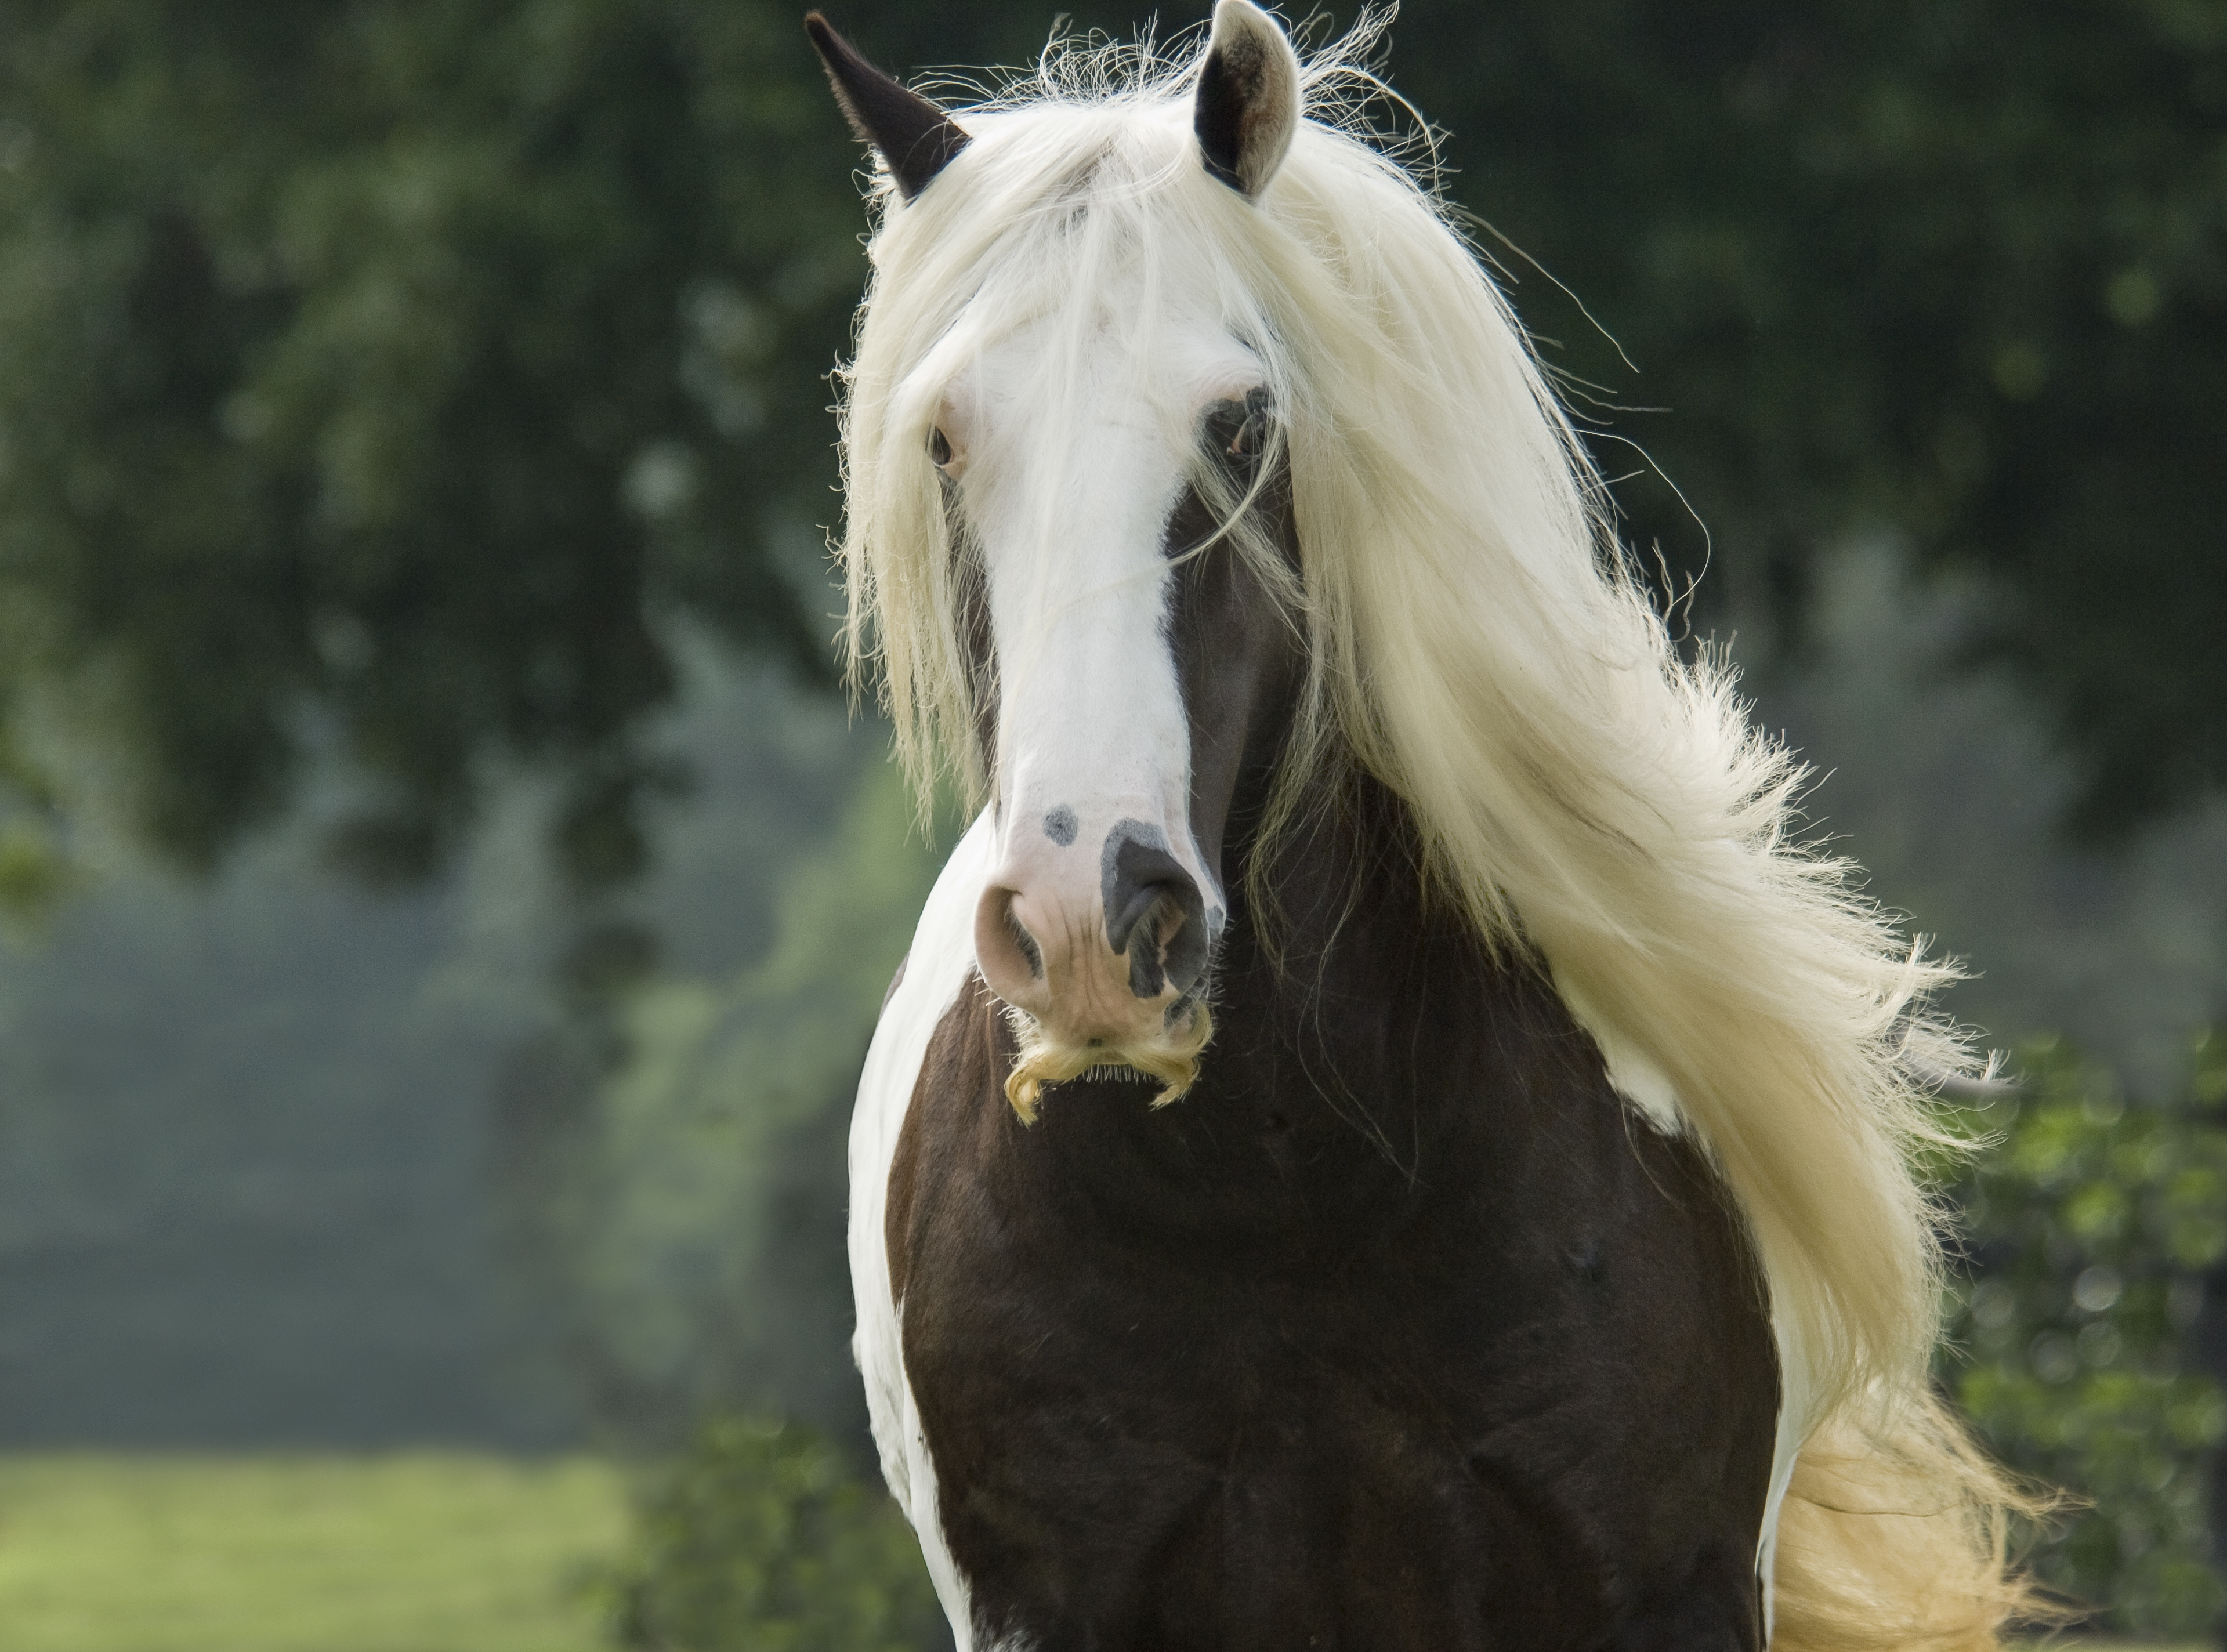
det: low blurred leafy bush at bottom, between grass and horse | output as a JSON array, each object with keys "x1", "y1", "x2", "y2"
[{"x1": 613, "y1": 1418, "x2": 951, "y2": 1652}]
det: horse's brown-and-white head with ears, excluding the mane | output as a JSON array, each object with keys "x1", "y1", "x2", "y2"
[{"x1": 810, "y1": 0, "x2": 1303, "y2": 1118}]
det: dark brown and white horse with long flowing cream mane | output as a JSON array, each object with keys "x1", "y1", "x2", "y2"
[{"x1": 806, "y1": 0, "x2": 2033, "y2": 1652}]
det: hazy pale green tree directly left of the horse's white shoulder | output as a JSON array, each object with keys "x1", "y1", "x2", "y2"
[{"x1": 544, "y1": 752, "x2": 948, "y2": 1443}]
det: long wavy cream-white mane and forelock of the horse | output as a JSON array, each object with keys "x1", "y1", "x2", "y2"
[{"x1": 842, "y1": 22, "x2": 2015, "y2": 1645}]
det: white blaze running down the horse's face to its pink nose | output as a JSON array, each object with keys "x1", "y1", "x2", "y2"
[{"x1": 940, "y1": 316, "x2": 1258, "y2": 1038}]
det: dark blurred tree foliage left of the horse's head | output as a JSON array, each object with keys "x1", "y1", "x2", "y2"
[{"x1": 0, "y1": 0, "x2": 862, "y2": 888}]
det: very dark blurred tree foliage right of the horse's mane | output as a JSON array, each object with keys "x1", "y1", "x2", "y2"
[{"x1": 1390, "y1": 0, "x2": 2227, "y2": 835}]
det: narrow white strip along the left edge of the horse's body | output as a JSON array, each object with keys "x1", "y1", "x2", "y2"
[{"x1": 850, "y1": 810, "x2": 993, "y2": 1652}]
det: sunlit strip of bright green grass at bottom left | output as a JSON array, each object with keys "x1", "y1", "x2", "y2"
[{"x1": 0, "y1": 1454, "x2": 628, "y2": 1652}]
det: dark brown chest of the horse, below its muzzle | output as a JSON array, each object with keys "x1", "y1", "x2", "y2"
[{"x1": 886, "y1": 995, "x2": 1777, "y2": 1652}]
